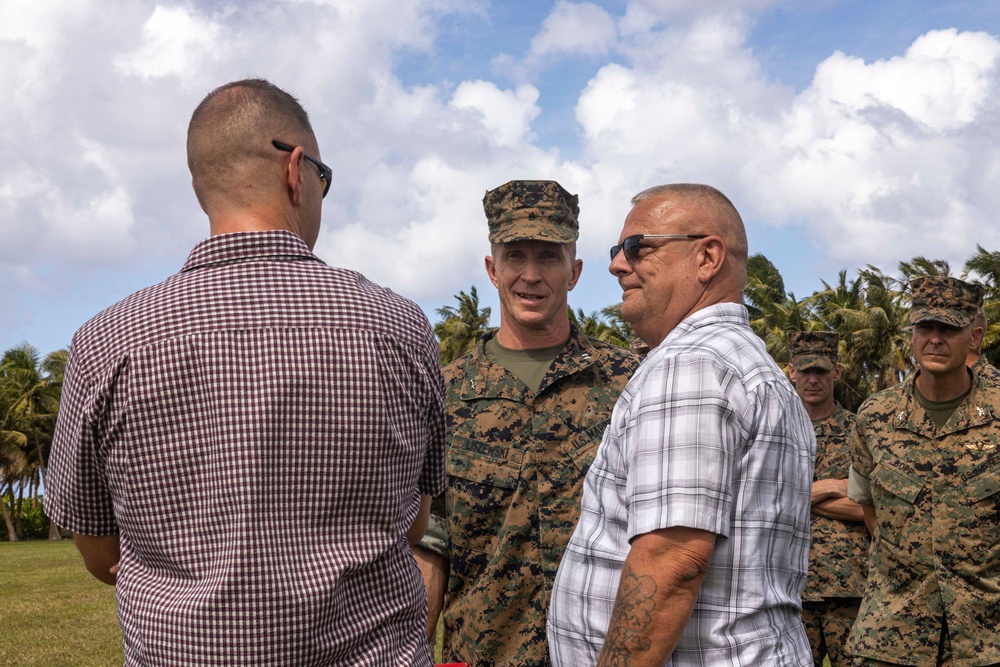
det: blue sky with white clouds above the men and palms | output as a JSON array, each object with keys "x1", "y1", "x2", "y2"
[{"x1": 0, "y1": 0, "x2": 1000, "y2": 360}]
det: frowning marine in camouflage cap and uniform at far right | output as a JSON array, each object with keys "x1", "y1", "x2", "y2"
[{"x1": 848, "y1": 276, "x2": 1000, "y2": 667}]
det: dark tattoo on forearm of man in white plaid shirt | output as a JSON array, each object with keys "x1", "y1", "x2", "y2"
[{"x1": 597, "y1": 564, "x2": 656, "y2": 667}]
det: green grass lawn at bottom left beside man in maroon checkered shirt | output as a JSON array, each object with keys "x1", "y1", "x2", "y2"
[{"x1": 0, "y1": 540, "x2": 123, "y2": 667}]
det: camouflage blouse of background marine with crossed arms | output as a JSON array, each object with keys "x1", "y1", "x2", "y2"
[{"x1": 802, "y1": 403, "x2": 868, "y2": 602}]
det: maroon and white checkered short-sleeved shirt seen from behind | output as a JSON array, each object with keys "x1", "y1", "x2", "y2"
[{"x1": 45, "y1": 232, "x2": 444, "y2": 665}]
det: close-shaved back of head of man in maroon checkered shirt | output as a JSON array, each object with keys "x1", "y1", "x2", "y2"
[{"x1": 187, "y1": 79, "x2": 317, "y2": 217}]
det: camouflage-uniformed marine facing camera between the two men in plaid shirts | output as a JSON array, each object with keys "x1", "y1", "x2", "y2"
[{"x1": 414, "y1": 181, "x2": 638, "y2": 667}]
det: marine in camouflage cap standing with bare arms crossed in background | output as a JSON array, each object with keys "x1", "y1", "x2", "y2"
[{"x1": 788, "y1": 331, "x2": 868, "y2": 667}]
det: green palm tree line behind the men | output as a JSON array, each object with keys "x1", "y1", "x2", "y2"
[{"x1": 7, "y1": 246, "x2": 1000, "y2": 541}]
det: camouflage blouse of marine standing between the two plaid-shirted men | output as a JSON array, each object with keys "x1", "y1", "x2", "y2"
[{"x1": 443, "y1": 329, "x2": 639, "y2": 667}]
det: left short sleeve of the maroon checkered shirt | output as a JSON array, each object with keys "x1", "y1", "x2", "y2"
[{"x1": 43, "y1": 344, "x2": 118, "y2": 535}]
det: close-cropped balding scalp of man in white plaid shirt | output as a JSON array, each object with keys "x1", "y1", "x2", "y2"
[{"x1": 632, "y1": 183, "x2": 748, "y2": 298}]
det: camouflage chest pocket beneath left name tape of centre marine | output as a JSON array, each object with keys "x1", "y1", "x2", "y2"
[{"x1": 445, "y1": 436, "x2": 523, "y2": 556}]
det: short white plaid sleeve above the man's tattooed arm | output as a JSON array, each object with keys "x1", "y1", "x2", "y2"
[{"x1": 625, "y1": 355, "x2": 738, "y2": 540}]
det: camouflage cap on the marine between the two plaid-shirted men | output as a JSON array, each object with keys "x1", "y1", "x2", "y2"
[{"x1": 483, "y1": 181, "x2": 580, "y2": 243}]
